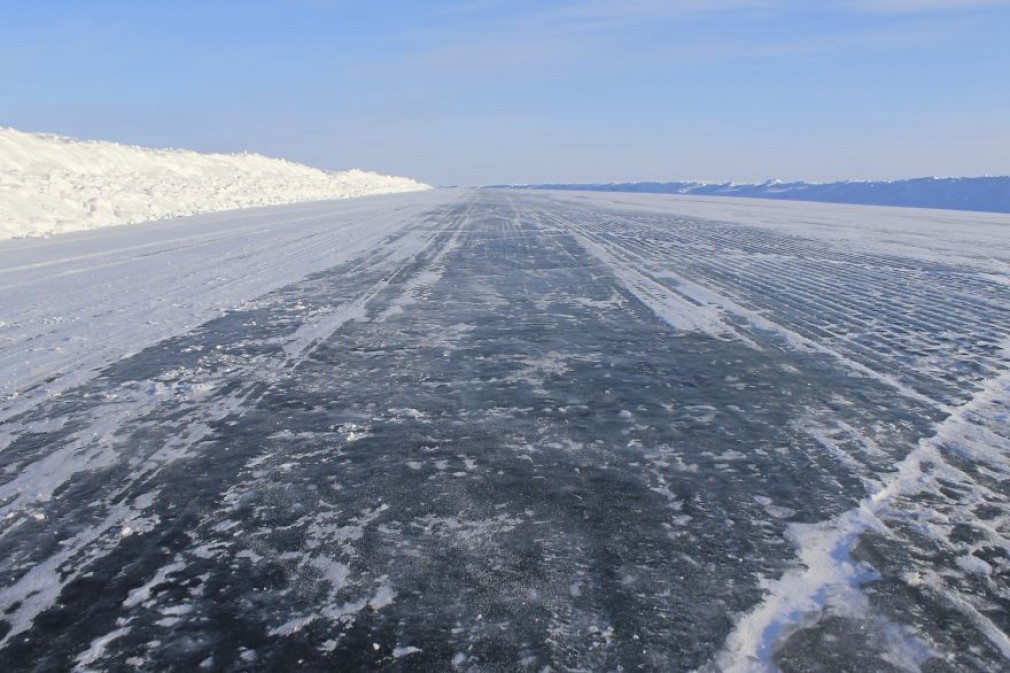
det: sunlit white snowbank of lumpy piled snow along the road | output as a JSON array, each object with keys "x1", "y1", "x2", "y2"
[{"x1": 0, "y1": 127, "x2": 429, "y2": 239}]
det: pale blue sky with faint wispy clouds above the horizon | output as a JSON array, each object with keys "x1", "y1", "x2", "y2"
[{"x1": 0, "y1": 0, "x2": 1010, "y2": 184}]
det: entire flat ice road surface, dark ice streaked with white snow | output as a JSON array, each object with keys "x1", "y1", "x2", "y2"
[{"x1": 0, "y1": 185, "x2": 1010, "y2": 671}]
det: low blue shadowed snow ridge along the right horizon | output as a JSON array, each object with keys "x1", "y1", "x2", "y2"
[{"x1": 514, "y1": 176, "x2": 1010, "y2": 212}]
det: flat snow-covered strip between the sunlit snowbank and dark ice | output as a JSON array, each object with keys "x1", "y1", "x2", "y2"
[{"x1": 0, "y1": 190, "x2": 452, "y2": 421}]
